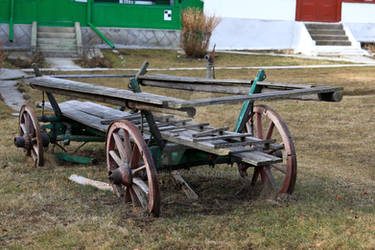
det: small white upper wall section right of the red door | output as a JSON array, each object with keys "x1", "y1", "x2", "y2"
[{"x1": 341, "y1": 3, "x2": 375, "y2": 23}]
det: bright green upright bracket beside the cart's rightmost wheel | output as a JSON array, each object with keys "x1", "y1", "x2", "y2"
[{"x1": 234, "y1": 69, "x2": 266, "y2": 133}]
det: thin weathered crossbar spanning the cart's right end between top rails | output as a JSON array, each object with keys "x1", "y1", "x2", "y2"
[{"x1": 180, "y1": 86, "x2": 343, "y2": 108}]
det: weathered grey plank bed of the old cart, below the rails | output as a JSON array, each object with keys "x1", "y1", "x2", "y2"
[{"x1": 50, "y1": 100, "x2": 282, "y2": 166}]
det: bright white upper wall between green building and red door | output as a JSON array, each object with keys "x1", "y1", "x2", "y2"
[{"x1": 204, "y1": 0, "x2": 297, "y2": 21}]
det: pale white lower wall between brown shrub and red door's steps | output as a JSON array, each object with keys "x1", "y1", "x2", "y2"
[{"x1": 211, "y1": 18, "x2": 314, "y2": 54}]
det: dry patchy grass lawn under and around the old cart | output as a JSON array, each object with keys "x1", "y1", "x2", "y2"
[{"x1": 0, "y1": 51, "x2": 375, "y2": 249}]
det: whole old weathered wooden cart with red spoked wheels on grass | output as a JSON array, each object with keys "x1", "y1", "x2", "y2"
[{"x1": 15, "y1": 64, "x2": 342, "y2": 216}]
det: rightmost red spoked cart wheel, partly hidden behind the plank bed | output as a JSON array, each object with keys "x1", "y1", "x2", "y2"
[{"x1": 240, "y1": 105, "x2": 297, "y2": 194}]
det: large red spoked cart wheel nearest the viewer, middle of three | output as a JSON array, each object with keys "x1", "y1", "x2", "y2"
[{"x1": 106, "y1": 120, "x2": 160, "y2": 216}]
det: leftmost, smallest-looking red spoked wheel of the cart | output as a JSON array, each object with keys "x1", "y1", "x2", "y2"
[{"x1": 18, "y1": 104, "x2": 44, "y2": 166}]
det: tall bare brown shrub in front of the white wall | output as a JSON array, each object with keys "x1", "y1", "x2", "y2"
[{"x1": 181, "y1": 8, "x2": 220, "y2": 58}]
